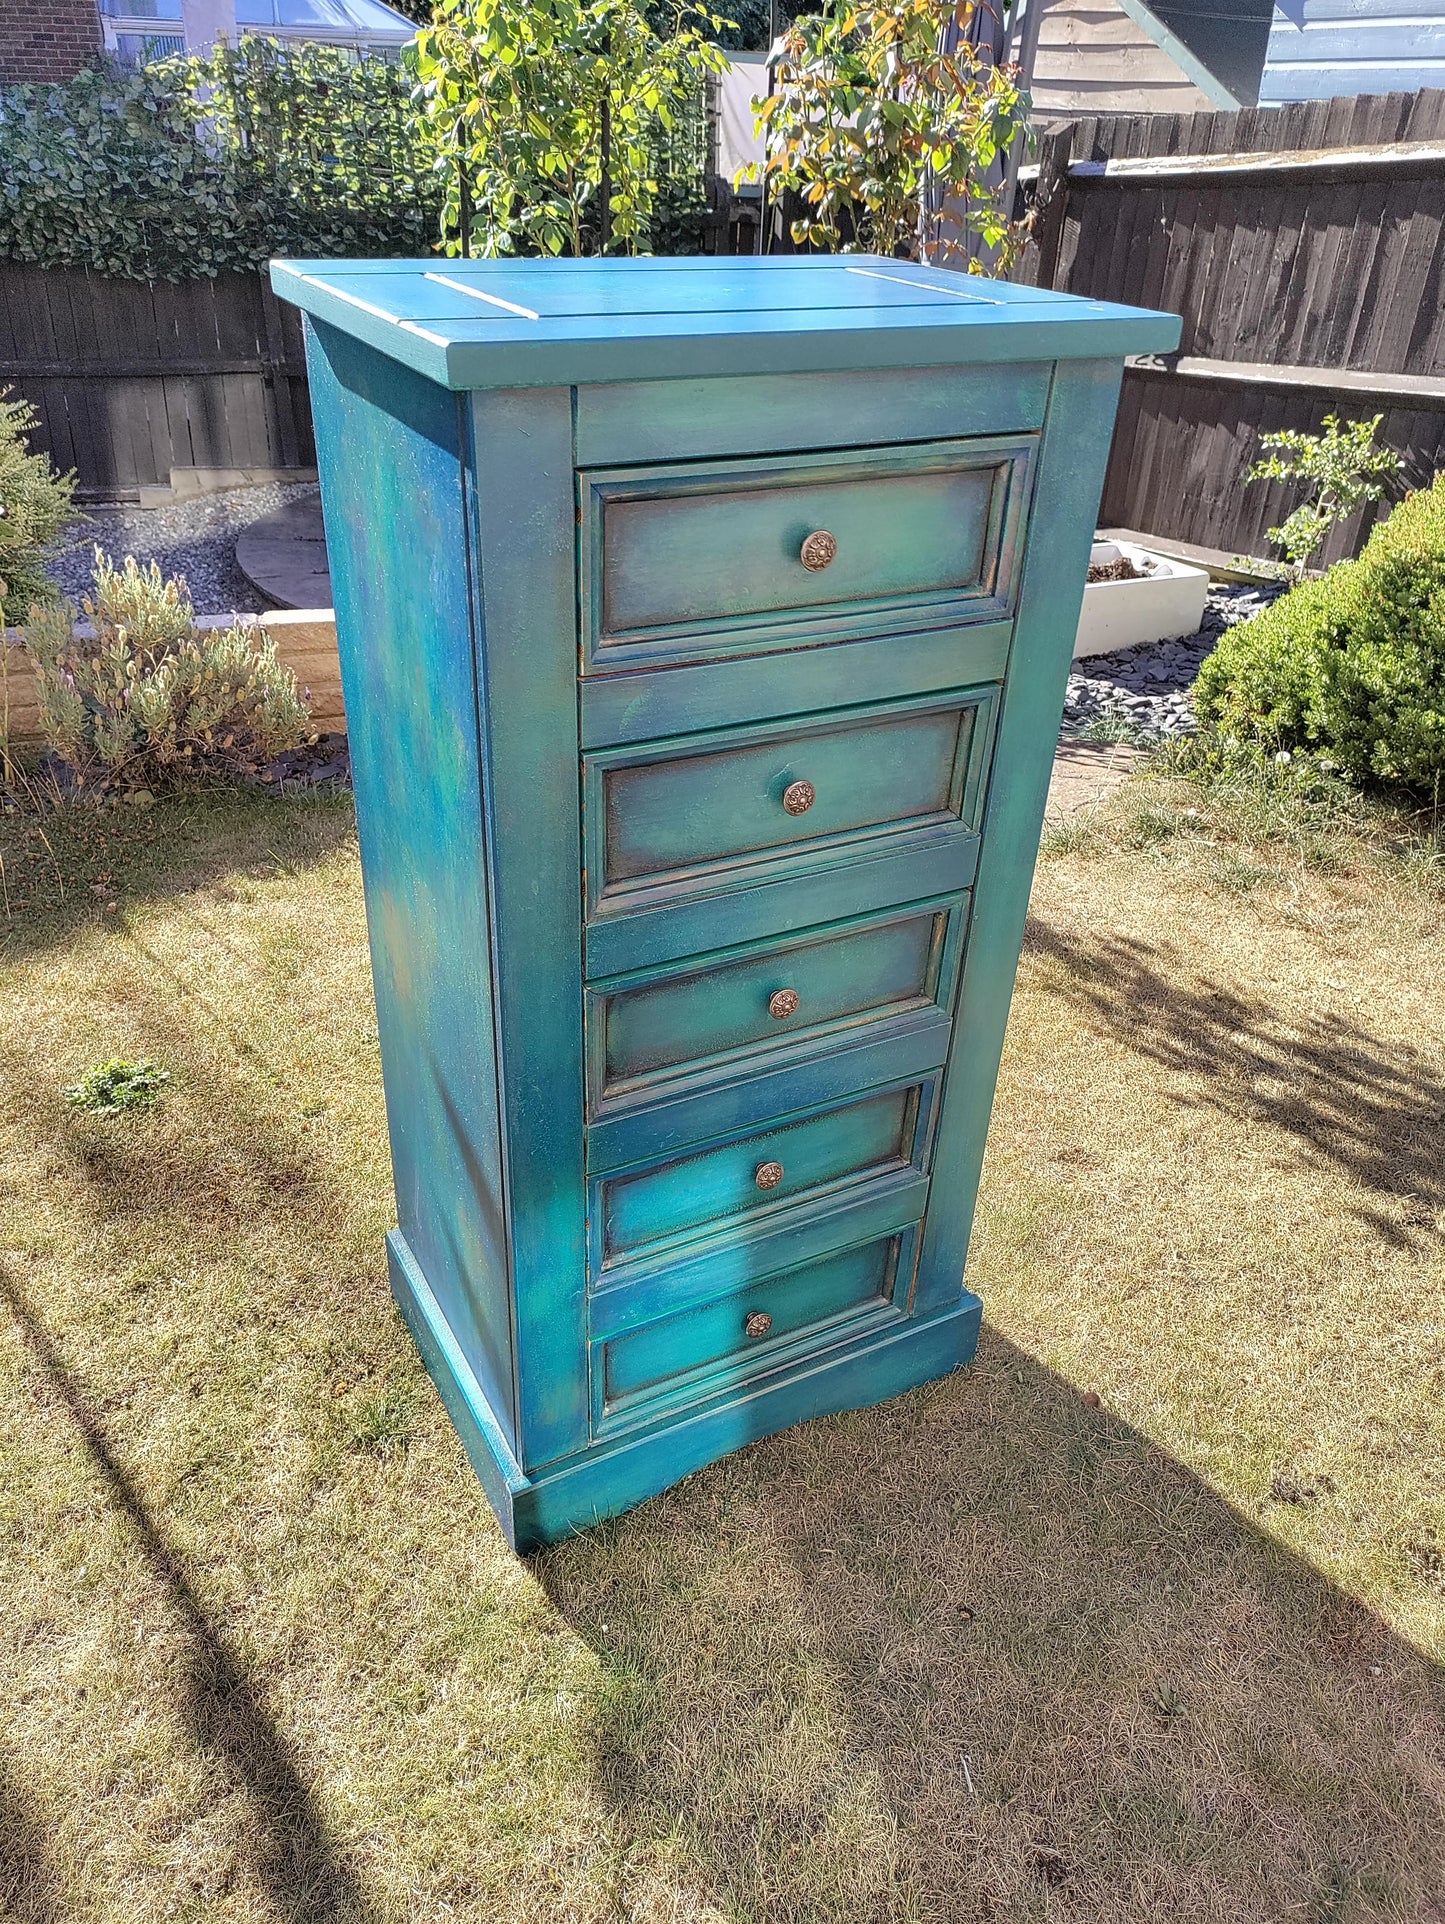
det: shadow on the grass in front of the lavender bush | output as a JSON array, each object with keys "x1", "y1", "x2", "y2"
[{"x1": 0, "y1": 791, "x2": 356, "y2": 960}]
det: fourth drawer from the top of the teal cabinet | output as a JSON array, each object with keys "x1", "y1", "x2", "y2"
[{"x1": 593, "y1": 1081, "x2": 935, "y2": 1279}]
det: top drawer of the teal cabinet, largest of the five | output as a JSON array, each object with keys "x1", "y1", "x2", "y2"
[{"x1": 581, "y1": 435, "x2": 1035, "y2": 673}]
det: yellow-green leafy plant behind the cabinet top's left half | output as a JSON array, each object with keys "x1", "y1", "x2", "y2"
[{"x1": 412, "y1": 0, "x2": 723, "y2": 254}]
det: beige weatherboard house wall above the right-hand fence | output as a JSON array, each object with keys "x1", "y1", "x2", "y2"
[{"x1": 1033, "y1": 0, "x2": 1216, "y2": 123}]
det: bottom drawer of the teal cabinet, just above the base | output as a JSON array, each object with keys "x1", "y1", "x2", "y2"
[{"x1": 600, "y1": 1229, "x2": 918, "y2": 1418}]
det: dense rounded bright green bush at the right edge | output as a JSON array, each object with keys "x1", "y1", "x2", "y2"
[{"x1": 1195, "y1": 475, "x2": 1445, "y2": 791}]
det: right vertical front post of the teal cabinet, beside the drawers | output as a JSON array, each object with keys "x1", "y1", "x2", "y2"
[{"x1": 916, "y1": 360, "x2": 1124, "y2": 1312}]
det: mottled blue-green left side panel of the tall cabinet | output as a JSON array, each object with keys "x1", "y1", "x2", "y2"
[{"x1": 308, "y1": 323, "x2": 516, "y2": 1445}]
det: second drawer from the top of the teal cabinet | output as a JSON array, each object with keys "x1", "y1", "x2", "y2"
[{"x1": 583, "y1": 687, "x2": 995, "y2": 918}]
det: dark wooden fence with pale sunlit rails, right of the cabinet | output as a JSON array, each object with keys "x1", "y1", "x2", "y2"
[{"x1": 1024, "y1": 92, "x2": 1445, "y2": 558}]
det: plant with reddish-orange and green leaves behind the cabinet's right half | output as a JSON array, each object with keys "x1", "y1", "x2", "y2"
[{"x1": 756, "y1": 0, "x2": 1029, "y2": 273}]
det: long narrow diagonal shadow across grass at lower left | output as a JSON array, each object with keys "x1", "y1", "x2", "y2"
[{"x1": 0, "y1": 1270, "x2": 371, "y2": 1924}]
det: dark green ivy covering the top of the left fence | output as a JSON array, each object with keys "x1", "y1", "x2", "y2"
[{"x1": 0, "y1": 37, "x2": 441, "y2": 281}]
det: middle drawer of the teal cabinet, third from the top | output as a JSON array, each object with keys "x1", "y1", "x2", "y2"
[{"x1": 587, "y1": 897, "x2": 966, "y2": 1114}]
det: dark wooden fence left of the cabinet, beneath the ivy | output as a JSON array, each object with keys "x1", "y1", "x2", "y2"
[{"x1": 0, "y1": 262, "x2": 316, "y2": 500}]
